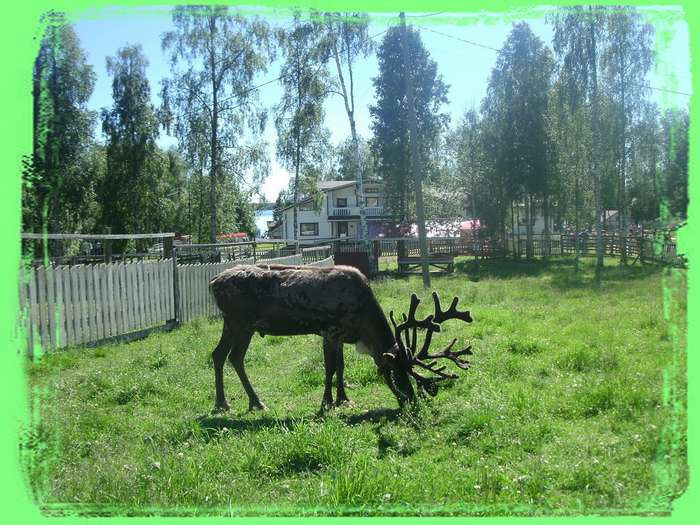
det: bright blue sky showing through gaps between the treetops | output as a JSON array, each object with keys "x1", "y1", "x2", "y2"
[{"x1": 68, "y1": 8, "x2": 691, "y2": 201}]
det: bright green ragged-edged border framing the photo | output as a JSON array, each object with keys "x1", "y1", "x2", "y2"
[{"x1": 0, "y1": 0, "x2": 700, "y2": 524}]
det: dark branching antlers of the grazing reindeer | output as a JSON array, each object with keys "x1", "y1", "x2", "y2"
[{"x1": 389, "y1": 292, "x2": 472, "y2": 392}]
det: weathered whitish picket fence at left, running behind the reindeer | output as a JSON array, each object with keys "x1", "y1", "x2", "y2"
[{"x1": 19, "y1": 254, "x2": 333, "y2": 357}]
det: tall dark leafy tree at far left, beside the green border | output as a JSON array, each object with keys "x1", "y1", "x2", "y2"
[{"x1": 22, "y1": 12, "x2": 97, "y2": 248}]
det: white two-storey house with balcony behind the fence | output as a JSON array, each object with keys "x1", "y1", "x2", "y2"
[{"x1": 270, "y1": 180, "x2": 393, "y2": 242}]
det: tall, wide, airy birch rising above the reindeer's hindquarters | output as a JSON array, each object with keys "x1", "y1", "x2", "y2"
[{"x1": 160, "y1": 6, "x2": 274, "y2": 242}]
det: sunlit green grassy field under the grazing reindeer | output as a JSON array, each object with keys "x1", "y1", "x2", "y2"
[{"x1": 22, "y1": 260, "x2": 688, "y2": 515}]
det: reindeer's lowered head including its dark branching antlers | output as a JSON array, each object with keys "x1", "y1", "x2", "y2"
[{"x1": 384, "y1": 292, "x2": 472, "y2": 403}]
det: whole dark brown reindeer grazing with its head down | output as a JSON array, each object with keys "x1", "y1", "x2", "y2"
[{"x1": 209, "y1": 264, "x2": 472, "y2": 410}]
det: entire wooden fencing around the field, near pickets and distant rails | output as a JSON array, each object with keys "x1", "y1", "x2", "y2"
[{"x1": 19, "y1": 227, "x2": 685, "y2": 356}]
